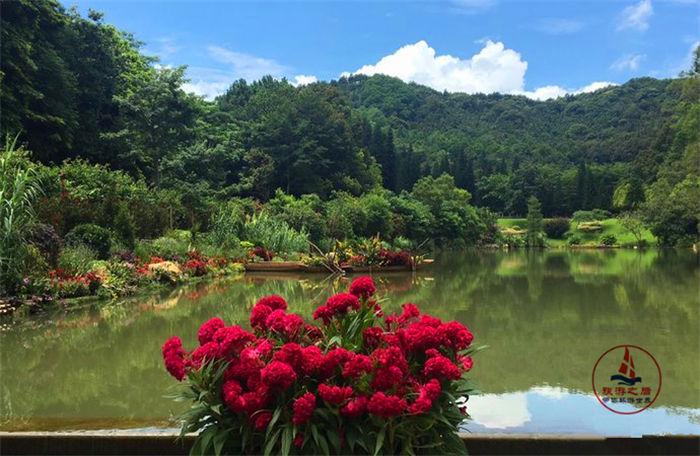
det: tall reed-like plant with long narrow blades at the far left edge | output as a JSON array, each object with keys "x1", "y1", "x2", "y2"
[{"x1": 0, "y1": 135, "x2": 41, "y2": 295}]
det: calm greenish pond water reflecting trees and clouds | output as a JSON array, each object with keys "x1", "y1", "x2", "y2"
[{"x1": 0, "y1": 251, "x2": 700, "y2": 436}]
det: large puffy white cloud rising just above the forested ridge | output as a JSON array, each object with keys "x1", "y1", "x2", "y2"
[{"x1": 348, "y1": 40, "x2": 612, "y2": 100}]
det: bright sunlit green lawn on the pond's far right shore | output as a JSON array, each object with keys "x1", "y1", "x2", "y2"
[{"x1": 498, "y1": 218, "x2": 657, "y2": 248}]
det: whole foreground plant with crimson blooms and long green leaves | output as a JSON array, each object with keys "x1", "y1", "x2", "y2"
[{"x1": 162, "y1": 277, "x2": 473, "y2": 454}]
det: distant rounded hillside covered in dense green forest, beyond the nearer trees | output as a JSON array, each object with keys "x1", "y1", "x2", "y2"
[{"x1": 332, "y1": 75, "x2": 680, "y2": 214}]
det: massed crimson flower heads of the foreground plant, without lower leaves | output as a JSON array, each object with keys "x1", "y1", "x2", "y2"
[{"x1": 163, "y1": 274, "x2": 473, "y2": 445}]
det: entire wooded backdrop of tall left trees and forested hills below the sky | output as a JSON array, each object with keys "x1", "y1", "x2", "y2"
[{"x1": 0, "y1": 0, "x2": 697, "y2": 223}]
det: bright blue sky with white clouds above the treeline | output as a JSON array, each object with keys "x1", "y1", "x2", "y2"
[{"x1": 64, "y1": 0, "x2": 700, "y2": 99}]
